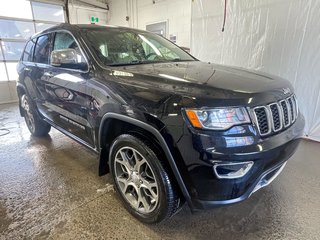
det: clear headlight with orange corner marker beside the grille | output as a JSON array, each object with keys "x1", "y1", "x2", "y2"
[{"x1": 186, "y1": 107, "x2": 250, "y2": 130}]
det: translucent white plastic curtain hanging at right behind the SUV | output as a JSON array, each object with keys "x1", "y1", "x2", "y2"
[{"x1": 191, "y1": 0, "x2": 320, "y2": 141}]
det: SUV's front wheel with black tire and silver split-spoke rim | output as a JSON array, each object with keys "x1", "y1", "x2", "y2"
[{"x1": 109, "y1": 134, "x2": 179, "y2": 223}]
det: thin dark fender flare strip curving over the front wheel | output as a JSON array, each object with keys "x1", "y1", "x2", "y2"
[{"x1": 99, "y1": 112, "x2": 193, "y2": 206}]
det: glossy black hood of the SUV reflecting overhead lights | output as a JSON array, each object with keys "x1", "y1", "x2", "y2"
[{"x1": 101, "y1": 61, "x2": 293, "y2": 111}]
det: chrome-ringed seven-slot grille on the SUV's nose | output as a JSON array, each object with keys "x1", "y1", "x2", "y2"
[{"x1": 253, "y1": 95, "x2": 298, "y2": 136}]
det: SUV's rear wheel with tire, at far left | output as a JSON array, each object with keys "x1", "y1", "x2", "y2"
[{"x1": 20, "y1": 94, "x2": 51, "y2": 137}]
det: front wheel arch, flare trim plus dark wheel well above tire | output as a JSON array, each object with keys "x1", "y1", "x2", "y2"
[{"x1": 99, "y1": 113, "x2": 191, "y2": 204}]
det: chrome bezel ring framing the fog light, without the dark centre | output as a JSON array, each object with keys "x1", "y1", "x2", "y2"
[{"x1": 211, "y1": 161, "x2": 253, "y2": 179}]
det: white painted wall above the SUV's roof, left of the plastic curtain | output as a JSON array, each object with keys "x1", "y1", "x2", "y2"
[{"x1": 109, "y1": 0, "x2": 191, "y2": 47}]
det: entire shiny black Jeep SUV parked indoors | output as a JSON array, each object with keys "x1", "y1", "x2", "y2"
[{"x1": 17, "y1": 24, "x2": 304, "y2": 223}]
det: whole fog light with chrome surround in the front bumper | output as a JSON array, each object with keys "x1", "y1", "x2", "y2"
[{"x1": 213, "y1": 161, "x2": 253, "y2": 179}]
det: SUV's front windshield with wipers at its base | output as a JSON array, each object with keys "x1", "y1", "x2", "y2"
[{"x1": 85, "y1": 28, "x2": 195, "y2": 66}]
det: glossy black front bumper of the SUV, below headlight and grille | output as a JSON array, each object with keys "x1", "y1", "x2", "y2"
[{"x1": 171, "y1": 114, "x2": 304, "y2": 209}]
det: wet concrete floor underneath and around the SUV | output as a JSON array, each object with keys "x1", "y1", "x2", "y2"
[{"x1": 0, "y1": 104, "x2": 320, "y2": 240}]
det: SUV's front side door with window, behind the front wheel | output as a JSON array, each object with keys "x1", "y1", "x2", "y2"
[{"x1": 39, "y1": 31, "x2": 94, "y2": 147}]
